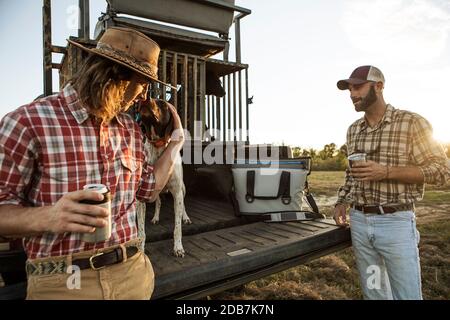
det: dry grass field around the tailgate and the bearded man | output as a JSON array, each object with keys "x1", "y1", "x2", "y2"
[{"x1": 211, "y1": 172, "x2": 450, "y2": 300}]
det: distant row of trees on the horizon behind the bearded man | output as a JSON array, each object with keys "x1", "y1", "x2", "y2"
[{"x1": 292, "y1": 143, "x2": 450, "y2": 171}]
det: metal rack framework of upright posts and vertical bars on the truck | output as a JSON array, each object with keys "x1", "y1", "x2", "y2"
[{"x1": 42, "y1": 0, "x2": 251, "y2": 144}]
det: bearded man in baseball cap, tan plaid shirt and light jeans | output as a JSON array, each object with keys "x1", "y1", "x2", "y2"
[{"x1": 334, "y1": 66, "x2": 450, "y2": 299}]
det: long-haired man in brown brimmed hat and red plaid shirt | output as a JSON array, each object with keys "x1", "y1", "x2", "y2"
[{"x1": 0, "y1": 28, "x2": 184, "y2": 299}]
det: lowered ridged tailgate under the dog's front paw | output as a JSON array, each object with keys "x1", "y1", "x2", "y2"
[{"x1": 146, "y1": 220, "x2": 350, "y2": 299}]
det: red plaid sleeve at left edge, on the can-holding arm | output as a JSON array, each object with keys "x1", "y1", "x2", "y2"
[{"x1": 0, "y1": 113, "x2": 36, "y2": 205}]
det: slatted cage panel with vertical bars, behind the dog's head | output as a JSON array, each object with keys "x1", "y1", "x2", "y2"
[{"x1": 150, "y1": 50, "x2": 249, "y2": 143}]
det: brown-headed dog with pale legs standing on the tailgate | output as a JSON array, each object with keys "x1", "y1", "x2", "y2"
[{"x1": 138, "y1": 99, "x2": 192, "y2": 257}]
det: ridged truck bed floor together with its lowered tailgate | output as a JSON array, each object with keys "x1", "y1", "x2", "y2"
[{"x1": 146, "y1": 197, "x2": 350, "y2": 299}]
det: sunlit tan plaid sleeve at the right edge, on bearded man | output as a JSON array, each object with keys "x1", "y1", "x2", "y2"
[{"x1": 411, "y1": 117, "x2": 450, "y2": 185}]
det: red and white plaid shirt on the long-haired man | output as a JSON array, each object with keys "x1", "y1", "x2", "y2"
[{"x1": 0, "y1": 85, "x2": 155, "y2": 259}]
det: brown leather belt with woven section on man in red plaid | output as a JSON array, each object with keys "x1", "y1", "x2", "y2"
[{"x1": 26, "y1": 245, "x2": 139, "y2": 276}]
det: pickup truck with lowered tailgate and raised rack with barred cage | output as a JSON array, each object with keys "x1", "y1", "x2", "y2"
[{"x1": 0, "y1": 0, "x2": 351, "y2": 299}]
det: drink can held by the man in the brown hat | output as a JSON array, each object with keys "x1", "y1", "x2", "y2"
[{"x1": 81, "y1": 184, "x2": 111, "y2": 243}]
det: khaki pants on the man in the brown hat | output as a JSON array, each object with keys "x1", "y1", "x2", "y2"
[{"x1": 27, "y1": 240, "x2": 155, "y2": 300}]
